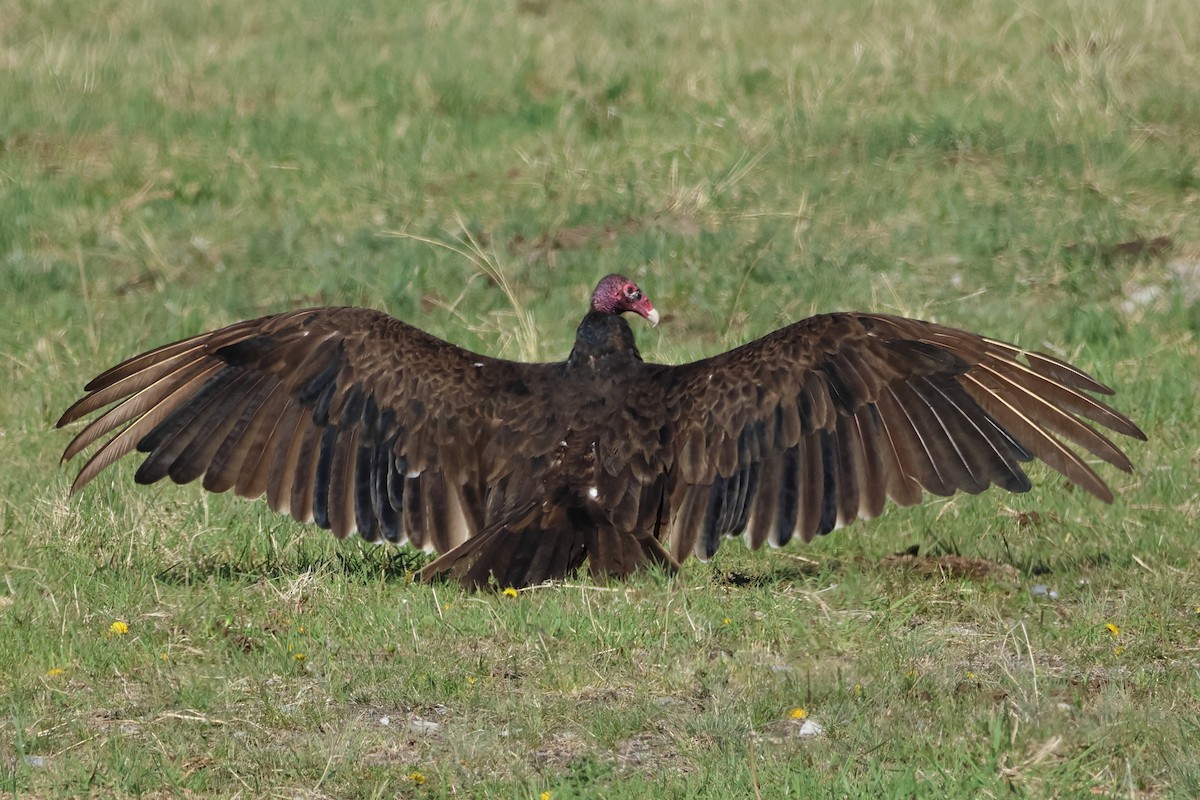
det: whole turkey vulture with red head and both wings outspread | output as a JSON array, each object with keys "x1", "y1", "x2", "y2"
[{"x1": 58, "y1": 275, "x2": 1146, "y2": 588}]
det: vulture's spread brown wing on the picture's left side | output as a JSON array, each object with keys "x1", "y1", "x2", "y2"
[{"x1": 58, "y1": 308, "x2": 560, "y2": 552}]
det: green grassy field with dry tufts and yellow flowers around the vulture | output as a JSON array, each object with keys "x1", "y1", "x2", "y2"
[{"x1": 0, "y1": 0, "x2": 1200, "y2": 800}]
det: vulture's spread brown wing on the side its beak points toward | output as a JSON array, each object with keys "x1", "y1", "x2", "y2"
[{"x1": 655, "y1": 313, "x2": 1145, "y2": 560}]
